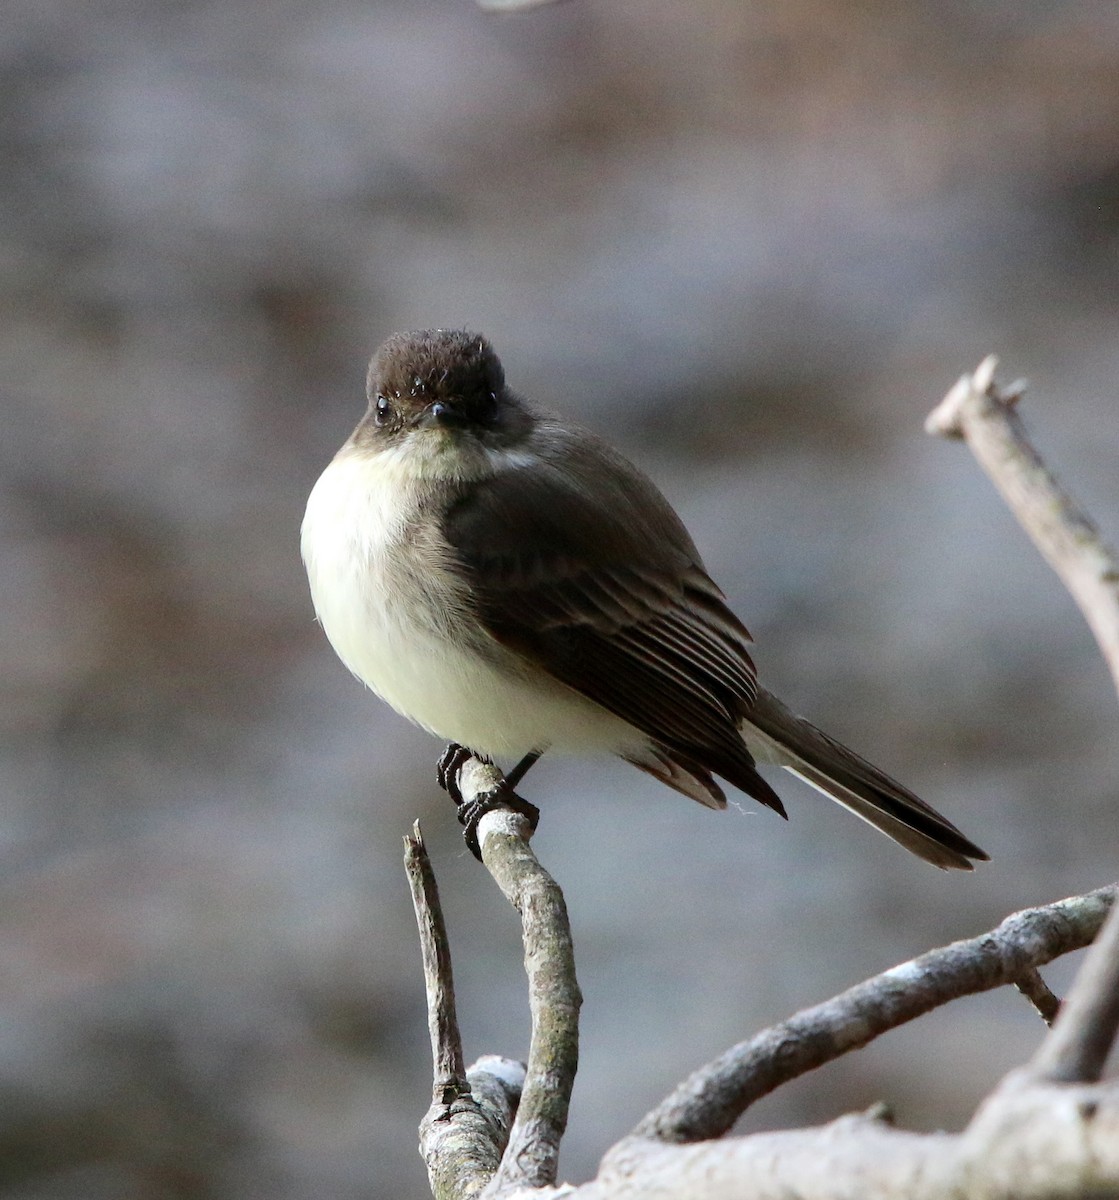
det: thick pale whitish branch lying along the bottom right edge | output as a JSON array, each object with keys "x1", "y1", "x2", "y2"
[{"x1": 581, "y1": 1073, "x2": 1119, "y2": 1200}]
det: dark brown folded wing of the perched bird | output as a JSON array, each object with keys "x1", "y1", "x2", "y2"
[{"x1": 443, "y1": 424, "x2": 783, "y2": 811}]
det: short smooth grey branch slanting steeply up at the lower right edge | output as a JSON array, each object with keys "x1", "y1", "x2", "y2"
[{"x1": 1031, "y1": 906, "x2": 1119, "y2": 1084}]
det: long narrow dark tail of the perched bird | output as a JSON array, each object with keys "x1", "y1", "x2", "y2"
[{"x1": 742, "y1": 688, "x2": 989, "y2": 871}]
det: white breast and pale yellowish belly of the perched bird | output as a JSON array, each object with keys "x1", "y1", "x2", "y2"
[{"x1": 303, "y1": 450, "x2": 645, "y2": 757}]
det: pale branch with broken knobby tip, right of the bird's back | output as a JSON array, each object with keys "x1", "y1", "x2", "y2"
[{"x1": 924, "y1": 355, "x2": 1119, "y2": 692}]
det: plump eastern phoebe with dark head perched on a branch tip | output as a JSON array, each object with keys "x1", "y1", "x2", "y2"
[{"x1": 303, "y1": 330, "x2": 987, "y2": 870}]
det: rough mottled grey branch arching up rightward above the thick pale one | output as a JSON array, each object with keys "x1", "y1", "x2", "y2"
[{"x1": 634, "y1": 887, "x2": 1119, "y2": 1142}]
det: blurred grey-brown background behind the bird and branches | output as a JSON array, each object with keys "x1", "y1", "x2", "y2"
[{"x1": 0, "y1": 0, "x2": 1119, "y2": 1200}]
